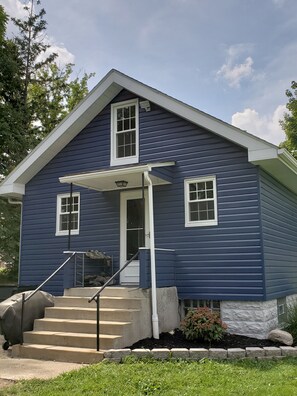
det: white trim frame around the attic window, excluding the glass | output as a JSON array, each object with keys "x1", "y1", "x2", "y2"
[{"x1": 110, "y1": 99, "x2": 139, "y2": 166}]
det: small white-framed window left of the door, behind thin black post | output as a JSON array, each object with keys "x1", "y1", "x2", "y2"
[{"x1": 56, "y1": 193, "x2": 80, "y2": 235}]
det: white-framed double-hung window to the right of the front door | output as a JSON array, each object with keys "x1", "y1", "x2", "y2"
[{"x1": 185, "y1": 176, "x2": 218, "y2": 227}]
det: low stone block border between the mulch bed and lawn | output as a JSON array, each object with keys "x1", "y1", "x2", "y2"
[{"x1": 104, "y1": 346, "x2": 297, "y2": 363}]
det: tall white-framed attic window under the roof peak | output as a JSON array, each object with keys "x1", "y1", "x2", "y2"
[{"x1": 110, "y1": 99, "x2": 139, "y2": 165}]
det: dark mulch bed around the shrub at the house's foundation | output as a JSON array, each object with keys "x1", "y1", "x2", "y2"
[{"x1": 129, "y1": 330, "x2": 282, "y2": 349}]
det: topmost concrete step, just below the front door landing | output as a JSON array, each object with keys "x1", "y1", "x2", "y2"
[{"x1": 64, "y1": 286, "x2": 149, "y2": 298}]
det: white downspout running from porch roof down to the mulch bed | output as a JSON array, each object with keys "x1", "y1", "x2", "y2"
[{"x1": 144, "y1": 171, "x2": 159, "y2": 339}]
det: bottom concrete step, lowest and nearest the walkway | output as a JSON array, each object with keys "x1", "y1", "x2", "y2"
[{"x1": 12, "y1": 344, "x2": 103, "y2": 364}]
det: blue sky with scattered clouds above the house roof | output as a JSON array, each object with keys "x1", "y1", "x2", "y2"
[{"x1": 0, "y1": 0, "x2": 297, "y2": 144}]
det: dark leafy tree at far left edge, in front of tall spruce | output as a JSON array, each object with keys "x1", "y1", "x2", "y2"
[{"x1": 0, "y1": 6, "x2": 25, "y2": 275}]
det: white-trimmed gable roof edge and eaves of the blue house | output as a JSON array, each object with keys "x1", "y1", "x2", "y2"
[{"x1": 0, "y1": 70, "x2": 297, "y2": 199}]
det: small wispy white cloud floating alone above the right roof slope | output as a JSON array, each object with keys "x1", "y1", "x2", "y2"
[{"x1": 217, "y1": 43, "x2": 254, "y2": 88}]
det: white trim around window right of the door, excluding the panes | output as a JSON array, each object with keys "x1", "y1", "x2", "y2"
[{"x1": 184, "y1": 176, "x2": 218, "y2": 227}]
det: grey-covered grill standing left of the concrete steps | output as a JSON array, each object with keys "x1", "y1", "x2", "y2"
[{"x1": 0, "y1": 290, "x2": 54, "y2": 349}]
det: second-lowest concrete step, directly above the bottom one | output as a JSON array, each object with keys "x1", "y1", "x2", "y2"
[{"x1": 24, "y1": 331, "x2": 123, "y2": 350}]
